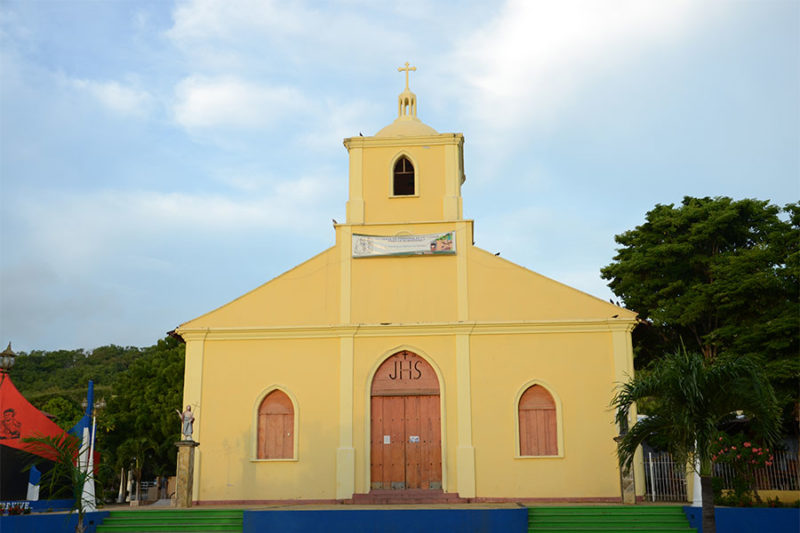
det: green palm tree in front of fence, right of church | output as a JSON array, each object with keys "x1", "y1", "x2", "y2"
[{"x1": 612, "y1": 348, "x2": 780, "y2": 533}]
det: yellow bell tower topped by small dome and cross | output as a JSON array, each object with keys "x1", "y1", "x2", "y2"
[{"x1": 344, "y1": 63, "x2": 465, "y2": 225}]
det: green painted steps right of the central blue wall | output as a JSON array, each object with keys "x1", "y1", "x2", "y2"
[{"x1": 528, "y1": 505, "x2": 696, "y2": 533}]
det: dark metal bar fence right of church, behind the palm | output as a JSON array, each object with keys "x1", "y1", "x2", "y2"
[{"x1": 644, "y1": 446, "x2": 800, "y2": 502}]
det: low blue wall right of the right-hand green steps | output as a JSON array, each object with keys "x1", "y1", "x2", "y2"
[{"x1": 683, "y1": 507, "x2": 800, "y2": 533}]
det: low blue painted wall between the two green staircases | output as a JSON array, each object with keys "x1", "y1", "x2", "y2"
[{"x1": 244, "y1": 507, "x2": 532, "y2": 533}]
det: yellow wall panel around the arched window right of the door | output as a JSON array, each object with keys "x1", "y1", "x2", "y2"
[{"x1": 471, "y1": 333, "x2": 619, "y2": 498}]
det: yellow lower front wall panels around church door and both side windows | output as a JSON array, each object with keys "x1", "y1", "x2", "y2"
[{"x1": 183, "y1": 322, "x2": 632, "y2": 501}]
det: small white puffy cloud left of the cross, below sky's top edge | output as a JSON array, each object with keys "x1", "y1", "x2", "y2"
[{"x1": 173, "y1": 76, "x2": 305, "y2": 129}]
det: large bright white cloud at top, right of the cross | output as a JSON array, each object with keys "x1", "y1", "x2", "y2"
[{"x1": 447, "y1": 0, "x2": 702, "y2": 129}]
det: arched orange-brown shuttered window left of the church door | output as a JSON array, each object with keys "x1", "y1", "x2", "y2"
[{"x1": 257, "y1": 389, "x2": 294, "y2": 459}]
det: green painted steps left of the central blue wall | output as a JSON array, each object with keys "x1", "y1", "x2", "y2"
[{"x1": 97, "y1": 509, "x2": 244, "y2": 533}]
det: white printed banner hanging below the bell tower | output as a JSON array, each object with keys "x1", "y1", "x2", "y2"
[{"x1": 353, "y1": 231, "x2": 456, "y2": 257}]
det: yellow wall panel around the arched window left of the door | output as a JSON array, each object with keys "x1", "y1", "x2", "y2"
[{"x1": 195, "y1": 339, "x2": 338, "y2": 501}]
